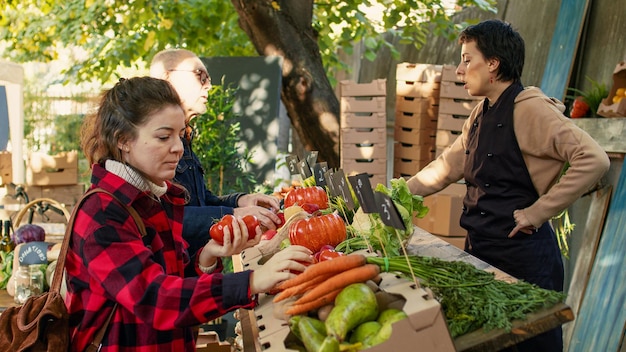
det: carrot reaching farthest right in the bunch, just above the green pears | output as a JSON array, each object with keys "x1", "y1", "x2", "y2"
[{"x1": 295, "y1": 259, "x2": 380, "y2": 304}]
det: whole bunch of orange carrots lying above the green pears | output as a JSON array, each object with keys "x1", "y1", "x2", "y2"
[{"x1": 274, "y1": 254, "x2": 380, "y2": 315}]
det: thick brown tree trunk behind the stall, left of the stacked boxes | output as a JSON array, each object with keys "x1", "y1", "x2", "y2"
[{"x1": 232, "y1": 0, "x2": 339, "y2": 168}]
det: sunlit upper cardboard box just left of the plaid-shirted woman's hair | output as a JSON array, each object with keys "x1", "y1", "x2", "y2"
[{"x1": 26, "y1": 151, "x2": 78, "y2": 186}]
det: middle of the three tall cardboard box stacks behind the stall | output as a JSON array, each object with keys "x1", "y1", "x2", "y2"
[{"x1": 393, "y1": 62, "x2": 442, "y2": 178}]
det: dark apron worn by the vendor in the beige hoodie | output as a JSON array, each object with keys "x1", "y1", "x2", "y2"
[{"x1": 461, "y1": 83, "x2": 563, "y2": 351}]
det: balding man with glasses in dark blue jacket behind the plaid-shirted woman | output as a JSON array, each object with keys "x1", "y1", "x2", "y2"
[{"x1": 150, "y1": 49, "x2": 280, "y2": 255}]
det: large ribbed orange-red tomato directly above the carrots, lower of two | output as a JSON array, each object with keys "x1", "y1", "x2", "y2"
[{"x1": 289, "y1": 213, "x2": 346, "y2": 253}]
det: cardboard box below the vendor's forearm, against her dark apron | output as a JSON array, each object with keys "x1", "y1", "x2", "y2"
[{"x1": 413, "y1": 183, "x2": 467, "y2": 237}]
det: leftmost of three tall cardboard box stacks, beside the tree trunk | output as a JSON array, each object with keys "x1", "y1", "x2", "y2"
[{"x1": 340, "y1": 79, "x2": 387, "y2": 187}]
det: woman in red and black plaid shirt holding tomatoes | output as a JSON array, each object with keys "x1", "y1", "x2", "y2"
[{"x1": 66, "y1": 77, "x2": 312, "y2": 352}]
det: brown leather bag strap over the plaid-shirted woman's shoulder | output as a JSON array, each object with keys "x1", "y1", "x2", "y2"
[{"x1": 50, "y1": 188, "x2": 146, "y2": 351}]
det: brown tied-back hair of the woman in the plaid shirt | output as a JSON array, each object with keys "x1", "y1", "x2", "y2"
[{"x1": 81, "y1": 77, "x2": 182, "y2": 165}]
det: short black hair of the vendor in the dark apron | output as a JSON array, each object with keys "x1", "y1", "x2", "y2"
[{"x1": 459, "y1": 20, "x2": 526, "y2": 82}]
